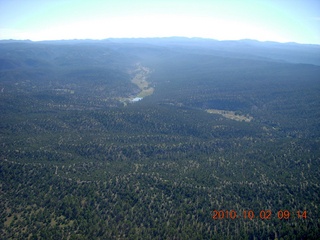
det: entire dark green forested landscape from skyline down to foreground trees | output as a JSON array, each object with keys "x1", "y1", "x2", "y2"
[{"x1": 0, "y1": 38, "x2": 320, "y2": 239}]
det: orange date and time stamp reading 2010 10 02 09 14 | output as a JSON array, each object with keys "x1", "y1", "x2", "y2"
[{"x1": 212, "y1": 209, "x2": 307, "y2": 220}]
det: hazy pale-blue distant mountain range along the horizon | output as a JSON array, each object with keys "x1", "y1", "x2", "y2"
[{"x1": 0, "y1": 37, "x2": 320, "y2": 65}]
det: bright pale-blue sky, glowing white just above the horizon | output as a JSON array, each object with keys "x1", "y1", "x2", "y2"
[{"x1": 0, "y1": 0, "x2": 320, "y2": 44}]
